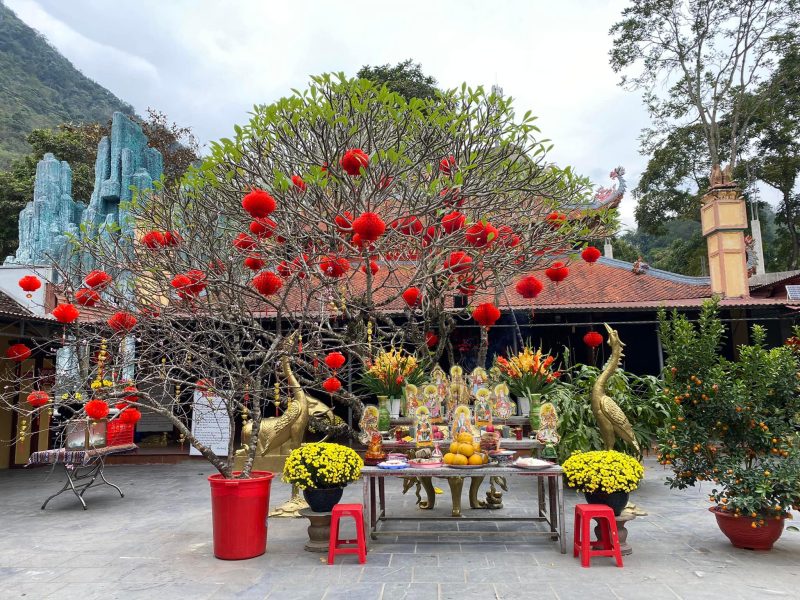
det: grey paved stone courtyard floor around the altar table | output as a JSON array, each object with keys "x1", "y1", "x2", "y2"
[{"x1": 0, "y1": 461, "x2": 800, "y2": 600}]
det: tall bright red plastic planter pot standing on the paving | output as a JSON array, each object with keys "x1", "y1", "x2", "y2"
[{"x1": 208, "y1": 471, "x2": 275, "y2": 560}]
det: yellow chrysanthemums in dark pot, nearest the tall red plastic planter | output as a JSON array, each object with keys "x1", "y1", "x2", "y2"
[{"x1": 283, "y1": 442, "x2": 364, "y2": 512}]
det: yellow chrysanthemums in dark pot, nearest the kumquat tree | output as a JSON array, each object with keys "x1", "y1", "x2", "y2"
[{"x1": 561, "y1": 450, "x2": 644, "y2": 516}]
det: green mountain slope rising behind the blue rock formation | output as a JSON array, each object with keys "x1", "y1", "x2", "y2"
[{"x1": 0, "y1": 0, "x2": 134, "y2": 169}]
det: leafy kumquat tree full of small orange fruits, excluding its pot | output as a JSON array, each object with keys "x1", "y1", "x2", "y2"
[{"x1": 659, "y1": 302, "x2": 800, "y2": 527}]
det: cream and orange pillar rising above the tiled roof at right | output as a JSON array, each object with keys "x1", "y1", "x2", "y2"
[{"x1": 700, "y1": 176, "x2": 750, "y2": 298}]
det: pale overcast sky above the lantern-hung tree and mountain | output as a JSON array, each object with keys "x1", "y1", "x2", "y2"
[{"x1": 5, "y1": 0, "x2": 664, "y2": 225}]
